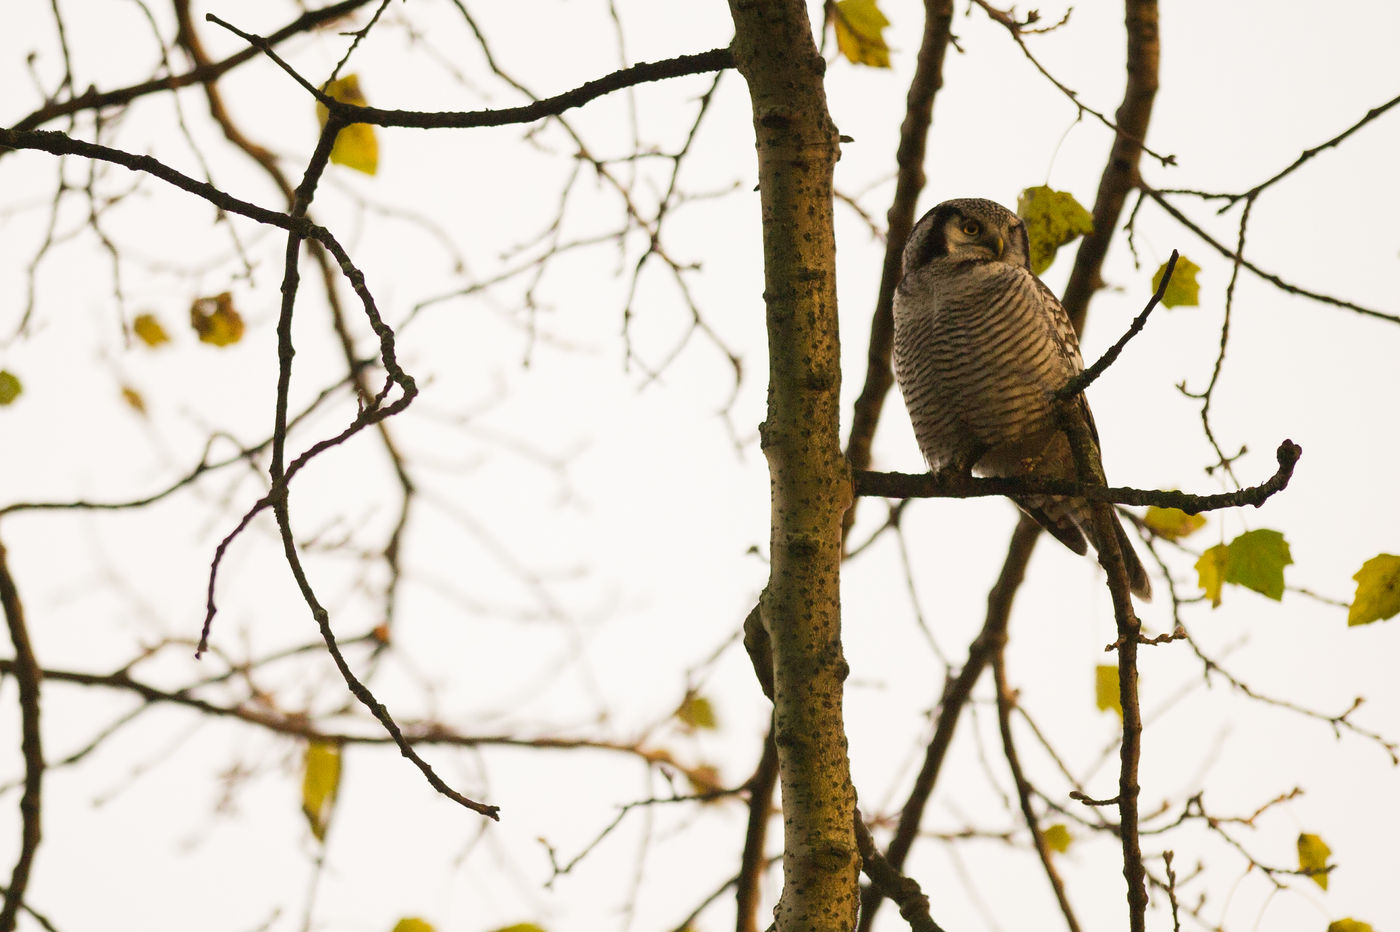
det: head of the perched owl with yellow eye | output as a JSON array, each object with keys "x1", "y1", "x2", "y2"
[{"x1": 904, "y1": 197, "x2": 1030, "y2": 274}]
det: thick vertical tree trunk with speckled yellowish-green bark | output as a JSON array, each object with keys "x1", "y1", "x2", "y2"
[{"x1": 729, "y1": 0, "x2": 860, "y2": 931}]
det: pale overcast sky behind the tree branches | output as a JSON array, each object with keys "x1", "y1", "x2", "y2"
[{"x1": 0, "y1": 0, "x2": 1400, "y2": 932}]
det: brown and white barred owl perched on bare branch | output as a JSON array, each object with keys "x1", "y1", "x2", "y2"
[{"x1": 895, "y1": 197, "x2": 1152, "y2": 599}]
